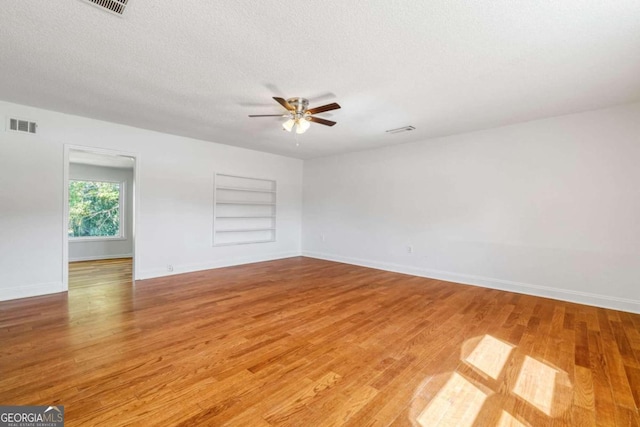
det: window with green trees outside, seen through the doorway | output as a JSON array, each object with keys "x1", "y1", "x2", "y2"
[{"x1": 69, "y1": 180, "x2": 124, "y2": 239}]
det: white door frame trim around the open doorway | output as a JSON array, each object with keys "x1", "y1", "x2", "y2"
[{"x1": 62, "y1": 144, "x2": 140, "y2": 292}]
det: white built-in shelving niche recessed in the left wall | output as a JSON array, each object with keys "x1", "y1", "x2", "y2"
[{"x1": 213, "y1": 174, "x2": 276, "y2": 246}]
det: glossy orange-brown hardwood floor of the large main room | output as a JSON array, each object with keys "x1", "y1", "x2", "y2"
[{"x1": 0, "y1": 258, "x2": 640, "y2": 426}]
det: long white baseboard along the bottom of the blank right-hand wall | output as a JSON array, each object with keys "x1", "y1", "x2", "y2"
[{"x1": 302, "y1": 251, "x2": 640, "y2": 313}]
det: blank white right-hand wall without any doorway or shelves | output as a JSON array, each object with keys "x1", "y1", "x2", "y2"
[{"x1": 302, "y1": 103, "x2": 640, "y2": 312}]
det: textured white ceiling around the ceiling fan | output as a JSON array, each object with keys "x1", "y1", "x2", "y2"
[{"x1": 0, "y1": 0, "x2": 640, "y2": 158}]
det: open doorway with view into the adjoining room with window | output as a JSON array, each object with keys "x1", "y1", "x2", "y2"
[{"x1": 63, "y1": 146, "x2": 137, "y2": 290}]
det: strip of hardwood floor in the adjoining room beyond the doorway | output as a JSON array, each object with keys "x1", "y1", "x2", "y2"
[{"x1": 69, "y1": 258, "x2": 133, "y2": 289}]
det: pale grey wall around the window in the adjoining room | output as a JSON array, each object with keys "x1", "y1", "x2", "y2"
[{"x1": 69, "y1": 163, "x2": 133, "y2": 261}]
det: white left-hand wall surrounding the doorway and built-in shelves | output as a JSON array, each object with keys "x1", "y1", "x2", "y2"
[{"x1": 0, "y1": 101, "x2": 302, "y2": 300}]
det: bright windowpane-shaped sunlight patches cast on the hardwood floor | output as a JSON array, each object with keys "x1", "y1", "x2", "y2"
[{"x1": 408, "y1": 335, "x2": 573, "y2": 427}]
